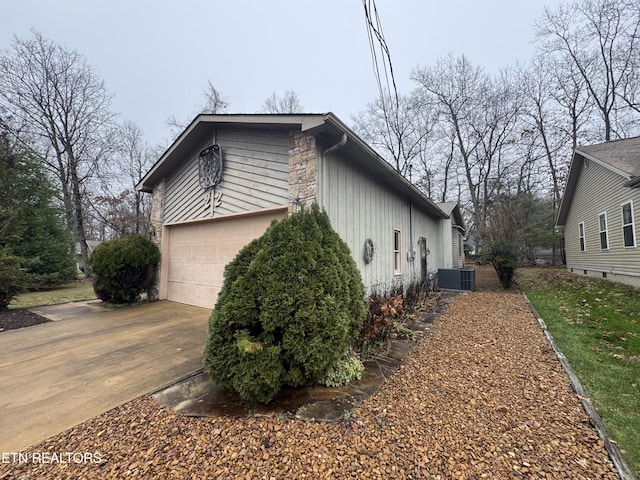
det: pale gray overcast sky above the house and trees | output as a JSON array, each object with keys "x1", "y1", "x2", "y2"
[{"x1": 0, "y1": 0, "x2": 568, "y2": 146}]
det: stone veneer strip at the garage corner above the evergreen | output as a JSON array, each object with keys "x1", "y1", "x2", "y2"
[{"x1": 289, "y1": 130, "x2": 318, "y2": 206}]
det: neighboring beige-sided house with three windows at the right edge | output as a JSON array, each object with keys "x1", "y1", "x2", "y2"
[{"x1": 556, "y1": 137, "x2": 640, "y2": 286}]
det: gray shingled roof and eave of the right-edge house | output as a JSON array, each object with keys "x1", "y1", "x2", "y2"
[{"x1": 556, "y1": 137, "x2": 640, "y2": 227}]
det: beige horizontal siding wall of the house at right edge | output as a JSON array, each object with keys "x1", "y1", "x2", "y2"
[{"x1": 564, "y1": 161, "x2": 640, "y2": 276}]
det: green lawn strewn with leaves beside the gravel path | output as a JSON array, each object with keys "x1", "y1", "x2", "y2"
[{"x1": 517, "y1": 268, "x2": 640, "y2": 475}]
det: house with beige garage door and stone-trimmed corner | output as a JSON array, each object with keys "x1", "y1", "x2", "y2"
[{"x1": 137, "y1": 113, "x2": 460, "y2": 307}]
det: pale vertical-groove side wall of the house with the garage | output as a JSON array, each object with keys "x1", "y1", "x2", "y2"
[{"x1": 318, "y1": 150, "x2": 442, "y2": 292}]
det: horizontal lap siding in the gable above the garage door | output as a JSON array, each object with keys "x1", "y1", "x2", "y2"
[{"x1": 164, "y1": 127, "x2": 289, "y2": 223}]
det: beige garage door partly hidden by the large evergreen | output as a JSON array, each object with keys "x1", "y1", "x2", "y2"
[{"x1": 160, "y1": 210, "x2": 286, "y2": 308}]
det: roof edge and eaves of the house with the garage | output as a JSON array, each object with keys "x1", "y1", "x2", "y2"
[{"x1": 136, "y1": 112, "x2": 449, "y2": 219}]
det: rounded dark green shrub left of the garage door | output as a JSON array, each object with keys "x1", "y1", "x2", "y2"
[{"x1": 89, "y1": 235, "x2": 160, "y2": 304}]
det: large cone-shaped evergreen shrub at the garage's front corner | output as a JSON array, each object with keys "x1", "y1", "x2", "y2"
[{"x1": 204, "y1": 205, "x2": 367, "y2": 403}]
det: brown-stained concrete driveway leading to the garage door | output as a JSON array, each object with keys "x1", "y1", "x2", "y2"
[{"x1": 0, "y1": 301, "x2": 211, "y2": 452}]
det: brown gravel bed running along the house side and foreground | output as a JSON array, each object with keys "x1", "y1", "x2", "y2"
[{"x1": 0, "y1": 286, "x2": 618, "y2": 479}]
